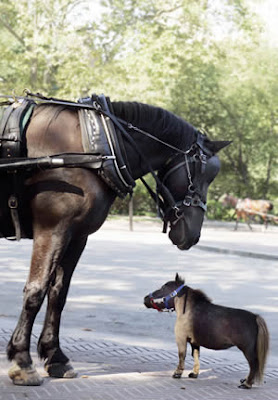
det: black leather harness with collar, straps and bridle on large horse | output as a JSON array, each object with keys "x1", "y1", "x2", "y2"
[{"x1": 0, "y1": 92, "x2": 211, "y2": 239}]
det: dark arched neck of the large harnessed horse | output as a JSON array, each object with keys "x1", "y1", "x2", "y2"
[{"x1": 112, "y1": 101, "x2": 196, "y2": 179}]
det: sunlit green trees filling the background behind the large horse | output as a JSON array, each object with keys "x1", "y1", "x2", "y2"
[{"x1": 0, "y1": 0, "x2": 278, "y2": 218}]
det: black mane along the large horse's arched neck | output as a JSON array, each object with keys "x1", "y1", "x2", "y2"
[{"x1": 112, "y1": 101, "x2": 196, "y2": 150}]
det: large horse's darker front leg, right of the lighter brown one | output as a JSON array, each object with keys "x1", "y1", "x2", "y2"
[{"x1": 38, "y1": 237, "x2": 87, "y2": 378}]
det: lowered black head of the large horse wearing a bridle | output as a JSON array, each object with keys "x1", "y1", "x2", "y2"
[{"x1": 159, "y1": 139, "x2": 230, "y2": 250}]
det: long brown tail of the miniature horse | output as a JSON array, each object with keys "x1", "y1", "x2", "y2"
[{"x1": 255, "y1": 315, "x2": 269, "y2": 382}]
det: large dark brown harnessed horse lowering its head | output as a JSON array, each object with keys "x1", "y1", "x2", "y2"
[{"x1": 1, "y1": 95, "x2": 228, "y2": 385}]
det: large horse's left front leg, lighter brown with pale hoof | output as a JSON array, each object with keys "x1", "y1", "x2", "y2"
[{"x1": 7, "y1": 232, "x2": 67, "y2": 386}]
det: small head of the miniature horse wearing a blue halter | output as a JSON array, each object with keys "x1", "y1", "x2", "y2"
[{"x1": 144, "y1": 274, "x2": 185, "y2": 311}]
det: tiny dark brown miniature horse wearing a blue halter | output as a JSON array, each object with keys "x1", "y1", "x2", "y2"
[{"x1": 144, "y1": 274, "x2": 269, "y2": 389}]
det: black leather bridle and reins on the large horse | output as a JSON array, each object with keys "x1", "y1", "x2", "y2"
[{"x1": 0, "y1": 90, "x2": 212, "y2": 228}]
